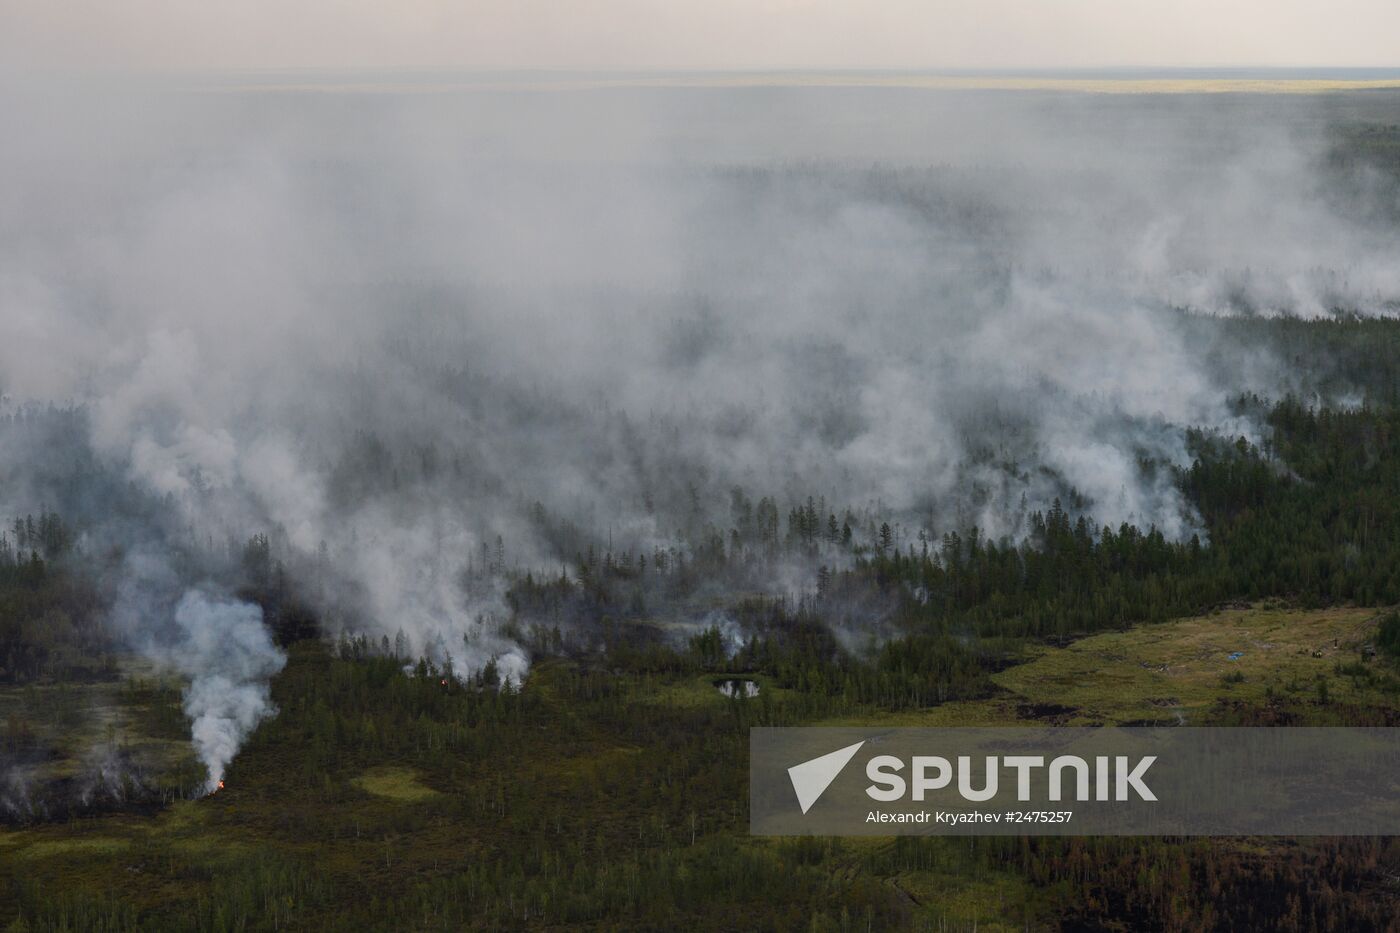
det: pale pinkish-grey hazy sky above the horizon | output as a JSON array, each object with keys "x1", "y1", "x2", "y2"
[{"x1": 0, "y1": 0, "x2": 1400, "y2": 70}]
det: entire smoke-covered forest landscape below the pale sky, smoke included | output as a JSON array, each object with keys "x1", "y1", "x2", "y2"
[{"x1": 0, "y1": 58, "x2": 1400, "y2": 932}]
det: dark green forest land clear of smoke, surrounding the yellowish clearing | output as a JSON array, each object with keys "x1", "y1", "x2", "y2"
[{"x1": 8, "y1": 322, "x2": 1400, "y2": 930}]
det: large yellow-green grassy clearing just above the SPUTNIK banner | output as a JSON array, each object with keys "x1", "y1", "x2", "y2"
[{"x1": 823, "y1": 605, "x2": 1400, "y2": 727}]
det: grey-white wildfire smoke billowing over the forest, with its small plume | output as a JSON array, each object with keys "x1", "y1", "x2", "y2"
[{"x1": 0, "y1": 79, "x2": 1400, "y2": 734}]
